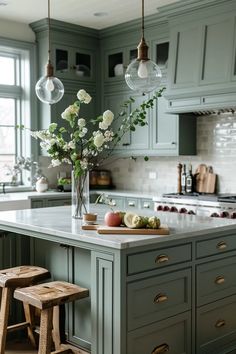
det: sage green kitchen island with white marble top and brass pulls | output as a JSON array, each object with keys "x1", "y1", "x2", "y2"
[{"x1": 0, "y1": 205, "x2": 236, "y2": 354}]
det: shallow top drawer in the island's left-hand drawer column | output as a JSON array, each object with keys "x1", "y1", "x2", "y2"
[{"x1": 128, "y1": 244, "x2": 192, "y2": 275}]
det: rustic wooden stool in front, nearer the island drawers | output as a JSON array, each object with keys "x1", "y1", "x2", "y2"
[{"x1": 14, "y1": 281, "x2": 89, "y2": 354}]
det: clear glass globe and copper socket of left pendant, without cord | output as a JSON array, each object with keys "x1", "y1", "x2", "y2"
[{"x1": 35, "y1": 63, "x2": 64, "y2": 104}]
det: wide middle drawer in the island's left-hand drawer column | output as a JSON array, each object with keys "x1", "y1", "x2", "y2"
[{"x1": 127, "y1": 269, "x2": 191, "y2": 330}]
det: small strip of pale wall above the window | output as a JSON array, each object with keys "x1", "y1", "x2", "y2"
[{"x1": 0, "y1": 19, "x2": 35, "y2": 42}]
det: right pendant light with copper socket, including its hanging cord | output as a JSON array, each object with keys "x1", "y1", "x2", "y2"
[{"x1": 125, "y1": 0, "x2": 162, "y2": 94}]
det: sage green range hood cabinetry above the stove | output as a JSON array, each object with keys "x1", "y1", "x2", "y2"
[{"x1": 165, "y1": 1, "x2": 236, "y2": 112}]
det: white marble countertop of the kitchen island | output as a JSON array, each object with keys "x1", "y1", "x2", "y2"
[{"x1": 0, "y1": 205, "x2": 236, "y2": 249}]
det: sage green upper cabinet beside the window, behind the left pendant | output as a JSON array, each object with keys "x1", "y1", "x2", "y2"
[{"x1": 30, "y1": 19, "x2": 100, "y2": 129}]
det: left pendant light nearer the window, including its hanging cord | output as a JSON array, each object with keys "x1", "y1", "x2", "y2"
[{"x1": 35, "y1": 0, "x2": 64, "y2": 104}]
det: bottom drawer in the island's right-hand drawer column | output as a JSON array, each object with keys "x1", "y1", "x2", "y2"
[{"x1": 197, "y1": 296, "x2": 236, "y2": 354}]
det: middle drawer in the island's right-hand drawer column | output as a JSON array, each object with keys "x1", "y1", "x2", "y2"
[{"x1": 197, "y1": 257, "x2": 236, "y2": 306}]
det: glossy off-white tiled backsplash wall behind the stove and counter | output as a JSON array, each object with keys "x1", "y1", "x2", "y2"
[{"x1": 104, "y1": 113, "x2": 236, "y2": 195}]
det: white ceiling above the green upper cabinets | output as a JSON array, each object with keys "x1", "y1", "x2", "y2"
[{"x1": 0, "y1": 0, "x2": 181, "y2": 29}]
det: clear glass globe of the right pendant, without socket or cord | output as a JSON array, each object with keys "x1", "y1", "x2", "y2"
[{"x1": 125, "y1": 59, "x2": 162, "y2": 93}]
